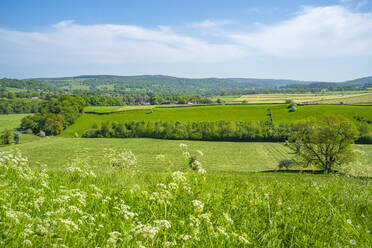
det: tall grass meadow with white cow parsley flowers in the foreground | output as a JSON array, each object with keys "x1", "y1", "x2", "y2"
[{"x1": 0, "y1": 146, "x2": 372, "y2": 247}]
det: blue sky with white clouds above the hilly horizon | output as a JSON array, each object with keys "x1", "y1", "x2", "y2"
[{"x1": 0, "y1": 0, "x2": 372, "y2": 82}]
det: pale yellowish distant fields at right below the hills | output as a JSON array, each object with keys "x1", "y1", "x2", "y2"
[{"x1": 232, "y1": 92, "x2": 372, "y2": 104}]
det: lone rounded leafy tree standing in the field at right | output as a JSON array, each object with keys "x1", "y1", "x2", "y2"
[{"x1": 286, "y1": 115, "x2": 358, "y2": 173}]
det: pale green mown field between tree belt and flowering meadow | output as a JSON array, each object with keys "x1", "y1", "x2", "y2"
[{"x1": 2, "y1": 137, "x2": 372, "y2": 175}]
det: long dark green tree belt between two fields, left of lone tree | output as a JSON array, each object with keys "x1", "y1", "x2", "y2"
[{"x1": 83, "y1": 121, "x2": 292, "y2": 141}]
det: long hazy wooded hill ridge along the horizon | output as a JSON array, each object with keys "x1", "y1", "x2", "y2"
[{"x1": 30, "y1": 75, "x2": 372, "y2": 95}]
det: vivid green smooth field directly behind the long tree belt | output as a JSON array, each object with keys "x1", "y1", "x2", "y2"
[{"x1": 62, "y1": 104, "x2": 372, "y2": 137}]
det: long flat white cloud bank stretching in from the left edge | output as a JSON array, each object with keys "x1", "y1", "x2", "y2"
[{"x1": 0, "y1": 21, "x2": 242, "y2": 64}]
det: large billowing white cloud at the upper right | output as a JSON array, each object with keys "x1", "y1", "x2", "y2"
[{"x1": 228, "y1": 6, "x2": 372, "y2": 58}]
